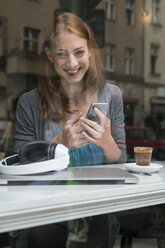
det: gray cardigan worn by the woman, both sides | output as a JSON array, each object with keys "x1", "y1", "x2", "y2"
[{"x1": 15, "y1": 83, "x2": 126, "y2": 163}]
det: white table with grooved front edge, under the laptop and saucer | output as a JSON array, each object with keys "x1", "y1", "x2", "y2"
[{"x1": 0, "y1": 165, "x2": 165, "y2": 232}]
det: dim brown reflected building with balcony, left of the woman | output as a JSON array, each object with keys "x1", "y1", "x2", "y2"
[{"x1": 0, "y1": 0, "x2": 59, "y2": 119}]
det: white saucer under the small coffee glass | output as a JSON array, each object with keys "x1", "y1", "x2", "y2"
[{"x1": 125, "y1": 163, "x2": 163, "y2": 173}]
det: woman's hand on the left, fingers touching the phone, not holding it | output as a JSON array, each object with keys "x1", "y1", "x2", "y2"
[{"x1": 51, "y1": 113, "x2": 89, "y2": 149}]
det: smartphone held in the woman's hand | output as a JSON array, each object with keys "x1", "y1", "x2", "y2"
[{"x1": 86, "y1": 102, "x2": 108, "y2": 124}]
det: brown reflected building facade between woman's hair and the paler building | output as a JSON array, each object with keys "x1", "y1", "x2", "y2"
[{"x1": 104, "y1": 0, "x2": 144, "y2": 125}]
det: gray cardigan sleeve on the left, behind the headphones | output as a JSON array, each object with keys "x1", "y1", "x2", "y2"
[{"x1": 15, "y1": 90, "x2": 43, "y2": 152}]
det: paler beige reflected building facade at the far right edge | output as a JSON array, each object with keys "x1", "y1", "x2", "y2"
[{"x1": 144, "y1": 0, "x2": 165, "y2": 128}]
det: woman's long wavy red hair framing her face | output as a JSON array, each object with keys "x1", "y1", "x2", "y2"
[{"x1": 39, "y1": 12, "x2": 105, "y2": 121}]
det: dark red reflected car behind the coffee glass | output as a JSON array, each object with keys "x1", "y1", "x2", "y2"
[{"x1": 125, "y1": 126, "x2": 165, "y2": 162}]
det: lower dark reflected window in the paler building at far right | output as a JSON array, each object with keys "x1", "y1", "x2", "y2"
[{"x1": 150, "y1": 45, "x2": 159, "y2": 75}]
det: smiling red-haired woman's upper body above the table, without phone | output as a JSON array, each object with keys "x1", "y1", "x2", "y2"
[{"x1": 16, "y1": 13, "x2": 126, "y2": 166}]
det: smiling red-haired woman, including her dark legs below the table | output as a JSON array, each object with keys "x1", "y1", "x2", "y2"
[{"x1": 12, "y1": 13, "x2": 126, "y2": 248}]
